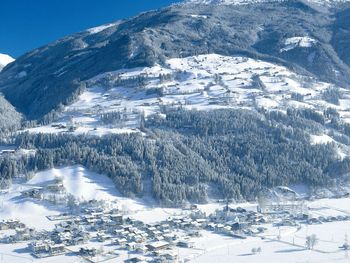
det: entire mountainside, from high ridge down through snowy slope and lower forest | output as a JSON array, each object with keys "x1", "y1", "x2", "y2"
[{"x1": 0, "y1": 0, "x2": 350, "y2": 206}]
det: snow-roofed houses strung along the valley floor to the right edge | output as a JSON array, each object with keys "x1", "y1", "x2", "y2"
[{"x1": 0, "y1": 194, "x2": 350, "y2": 262}]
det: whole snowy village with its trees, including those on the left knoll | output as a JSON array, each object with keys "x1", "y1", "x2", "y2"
[{"x1": 0, "y1": 176, "x2": 350, "y2": 262}]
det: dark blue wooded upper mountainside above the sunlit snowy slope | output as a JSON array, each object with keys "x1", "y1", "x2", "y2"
[{"x1": 0, "y1": 0, "x2": 350, "y2": 119}]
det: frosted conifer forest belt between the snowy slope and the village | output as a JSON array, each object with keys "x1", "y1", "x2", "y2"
[{"x1": 0, "y1": 108, "x2": 350, "y2": 206}]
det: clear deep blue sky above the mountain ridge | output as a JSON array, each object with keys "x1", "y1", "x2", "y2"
[{"x1": 0, "y1": 0, "x2": 179, "y2": 57}]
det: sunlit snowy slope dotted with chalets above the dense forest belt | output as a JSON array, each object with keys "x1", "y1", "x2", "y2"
[{"x1": 26, "y1": 52, "x2": 350, "y2": 135}]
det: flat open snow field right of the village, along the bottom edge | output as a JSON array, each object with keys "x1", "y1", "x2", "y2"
[{"x1": 190, "y1": 229, "x2": 349, "y2": 263}]
